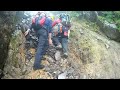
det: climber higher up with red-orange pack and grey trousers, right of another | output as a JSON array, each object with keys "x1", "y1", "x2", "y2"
[{"x1": 52, "y1": 14, "x2": 71, "y2": 58}]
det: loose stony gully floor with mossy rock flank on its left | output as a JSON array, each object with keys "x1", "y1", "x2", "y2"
[{"x1": 2, "y1": 32, "x2": 80, "y2": 79}]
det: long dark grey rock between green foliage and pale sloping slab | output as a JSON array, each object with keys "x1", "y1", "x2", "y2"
[{"x1": 82, "y1": 11, "x2": 120, "y2": 42}]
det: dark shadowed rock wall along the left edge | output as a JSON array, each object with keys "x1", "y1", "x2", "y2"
[{"x1": 0, "y1": 11, "x2": 21, "y2": 78}]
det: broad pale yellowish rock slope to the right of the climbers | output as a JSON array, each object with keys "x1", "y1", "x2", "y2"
[{"x1": 69, "y1": 23, "x2": 120, "y2": 79}]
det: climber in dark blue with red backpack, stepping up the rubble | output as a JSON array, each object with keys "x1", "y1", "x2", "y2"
[{"x1": 26, "y1": 12, "x2": 52, "y2": 70}]
